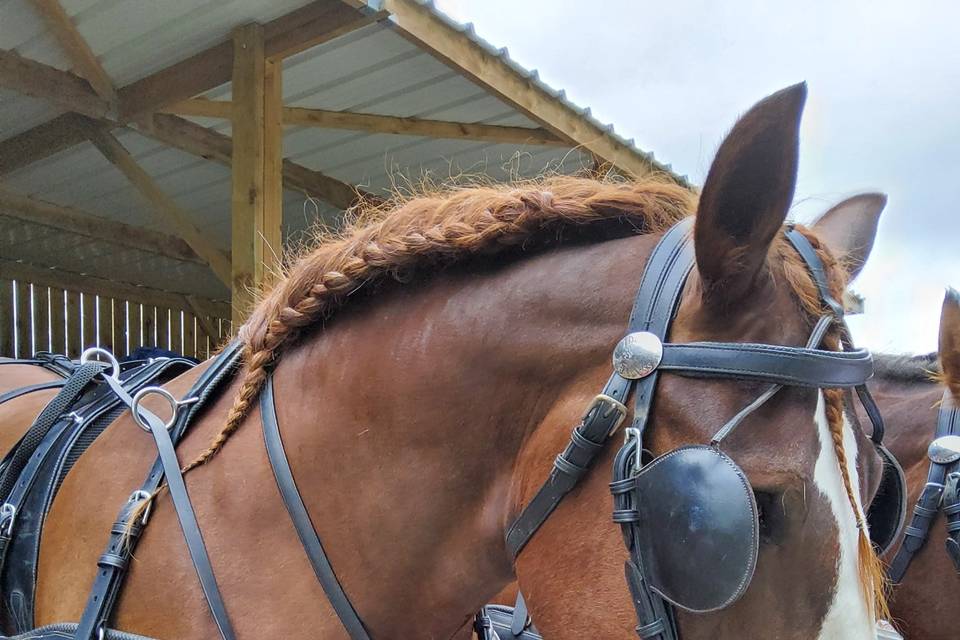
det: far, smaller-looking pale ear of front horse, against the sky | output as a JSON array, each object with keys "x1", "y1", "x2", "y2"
[{"x1": 813, "y1": 193, "x2": 887, "y2": 280}]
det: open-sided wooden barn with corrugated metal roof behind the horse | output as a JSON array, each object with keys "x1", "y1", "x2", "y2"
[{"x1": 0, "y1": 0, "x2": 684, "y2": 358}]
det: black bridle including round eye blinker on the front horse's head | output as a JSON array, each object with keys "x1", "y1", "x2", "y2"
[{"x1": 506, "y1": 219, "x2": 883, "y2": 640}]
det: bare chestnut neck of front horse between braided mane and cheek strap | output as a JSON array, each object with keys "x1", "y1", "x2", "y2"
[{"x1": 276, "y1": 232, "x2": 651, "y2": 631}]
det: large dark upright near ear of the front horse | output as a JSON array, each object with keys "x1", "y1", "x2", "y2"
[{"x1": 694, "y1": 83, "x2": 807, "y2": 307}]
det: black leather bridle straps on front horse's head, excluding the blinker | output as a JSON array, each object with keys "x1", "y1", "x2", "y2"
[{"x1": 506, "y1": 219, "x2": 883, "y2": 640}]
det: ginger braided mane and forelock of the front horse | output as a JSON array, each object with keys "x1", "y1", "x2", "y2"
[{"x1": 163, "y1": 176, "x2": 887, "y2": 615}]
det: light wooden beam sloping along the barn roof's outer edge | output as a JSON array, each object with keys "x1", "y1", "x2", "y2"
[{"x1": 382, "y1": 0, "x2": 680, "y2": 180}]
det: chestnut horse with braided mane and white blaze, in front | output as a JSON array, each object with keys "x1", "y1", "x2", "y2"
[{"x1": 0, "y1": 85, "x2": 880, "y2": 640}]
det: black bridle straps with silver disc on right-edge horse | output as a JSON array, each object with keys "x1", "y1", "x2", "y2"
[{"x1": 888, "y1": 390, "x2": 960, "y2": 583}]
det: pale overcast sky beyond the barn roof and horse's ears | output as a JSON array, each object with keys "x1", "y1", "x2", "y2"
[{"x1": 437, "y1": 0, "x2": 960, "y2": 352}]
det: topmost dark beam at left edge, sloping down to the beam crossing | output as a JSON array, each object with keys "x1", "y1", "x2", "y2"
[{"x1": 0, "y1": 50, "x2": 111, "y2": 118}]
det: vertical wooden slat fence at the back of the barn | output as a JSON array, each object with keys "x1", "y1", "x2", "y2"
[{"x1": 0, "y1": 279, "x2": 230, "y2": 360}]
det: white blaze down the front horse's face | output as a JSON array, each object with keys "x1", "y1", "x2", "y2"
[{"x1": 813, "y1": 392, "x2": 875, "y2": 640}]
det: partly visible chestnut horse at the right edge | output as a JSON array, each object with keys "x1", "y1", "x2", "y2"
[{"x1": 870, "y1": 291, "x2": 960, "y2": 640}]
